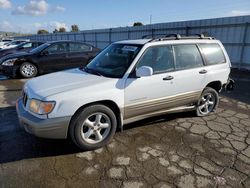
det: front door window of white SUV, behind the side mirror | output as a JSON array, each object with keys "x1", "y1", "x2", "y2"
[{"x1": 136, "y1": 45, "x2": 174, "y2": 74}]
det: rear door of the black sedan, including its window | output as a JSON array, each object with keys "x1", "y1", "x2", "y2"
[{"x1": 68, "y1": 43, "x2": 92, "y2": 68}]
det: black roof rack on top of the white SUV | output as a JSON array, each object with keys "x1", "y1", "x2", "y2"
[{"x1": 146, "y1": 34, "x2": 215, "y2": 42}]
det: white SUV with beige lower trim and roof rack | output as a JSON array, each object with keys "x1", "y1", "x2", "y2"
[{"x1": 17, "y1": 35, "x2": 232, "y2": 149}]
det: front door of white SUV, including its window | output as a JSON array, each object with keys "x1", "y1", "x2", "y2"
[{"x1": 124, "y1": 45, "x2": 176, "y2": 119}]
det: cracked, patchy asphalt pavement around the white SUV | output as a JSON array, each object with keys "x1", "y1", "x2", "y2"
[{"x1": 0, "y1": 71, "x2": 250, "y2": 188}]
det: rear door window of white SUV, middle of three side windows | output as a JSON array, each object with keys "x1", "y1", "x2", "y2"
[{"x1": 173, "y1": 44, "x2": 203, "y2": 70}]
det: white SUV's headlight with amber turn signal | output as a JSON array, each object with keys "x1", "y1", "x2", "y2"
[{"x1": 29, "y1": 99, "x2": 56, "y2": 115}]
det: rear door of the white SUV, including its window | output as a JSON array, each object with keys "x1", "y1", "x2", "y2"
[{"x1": 173, "y1": 44, "x2": 207, "y2": 97}]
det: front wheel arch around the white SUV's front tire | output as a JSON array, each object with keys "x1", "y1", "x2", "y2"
[{"x1": 67, "y1": 100, "x2": 123, "y2": 137}]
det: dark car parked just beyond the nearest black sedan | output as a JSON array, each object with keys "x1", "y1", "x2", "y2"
[{"x1": 0, "y1": 41, "x2": 44, "y2": 58}]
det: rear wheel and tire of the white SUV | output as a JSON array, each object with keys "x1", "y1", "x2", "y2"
[{"x1": 196, "y1": 87, "x2": 219, "y2": 117}]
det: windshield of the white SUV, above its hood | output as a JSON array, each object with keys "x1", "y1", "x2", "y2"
[{"x1": 85, "y1": 44, "x2": 142, "y2": 78}]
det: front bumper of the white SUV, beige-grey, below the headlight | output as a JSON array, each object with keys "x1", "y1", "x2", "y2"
[{"x1": 16, "y1": 99, "x2": 71, "y2": 139}]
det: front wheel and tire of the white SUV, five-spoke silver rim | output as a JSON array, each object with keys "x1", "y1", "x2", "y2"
[{"x1": 69, "y1": 105, "x2": 117, "y2": 150}]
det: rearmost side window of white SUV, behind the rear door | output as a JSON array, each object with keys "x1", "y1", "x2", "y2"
[{"x1": 199, "y1": 44, "x2": 226, "y2": 65}]
